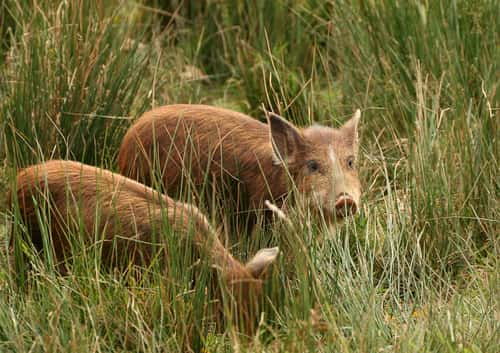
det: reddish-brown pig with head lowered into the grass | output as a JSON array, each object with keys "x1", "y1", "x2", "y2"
[{"x1": 11, "y1": 160, "x2": 278, "y2": 331}]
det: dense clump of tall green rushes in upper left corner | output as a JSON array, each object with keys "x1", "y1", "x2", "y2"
[{"x1": 1, "y1": 1, "x2": 147, "y2": 166}]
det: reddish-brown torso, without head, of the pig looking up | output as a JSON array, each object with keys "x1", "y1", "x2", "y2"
[{"x1": 118, "y1": 104, "x2": 272, "y2": 193}]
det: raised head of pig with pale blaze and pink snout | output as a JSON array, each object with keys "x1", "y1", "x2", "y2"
[{"x1": 268, "y1": 109, "x2": 361, "y2": 223}]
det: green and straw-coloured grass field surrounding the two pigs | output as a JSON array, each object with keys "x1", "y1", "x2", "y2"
[{"x1": 0, "y1": 0, "x2": 500, "y2": 353}]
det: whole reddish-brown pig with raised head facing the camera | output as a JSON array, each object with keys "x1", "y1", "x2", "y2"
[{"x1": 118, "y1": 104, "x2": 361, "y2": 226}]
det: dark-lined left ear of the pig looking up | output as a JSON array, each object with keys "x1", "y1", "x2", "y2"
[{"x1": 266, "y1": 112, "x2": 304, "y2": 164}]
